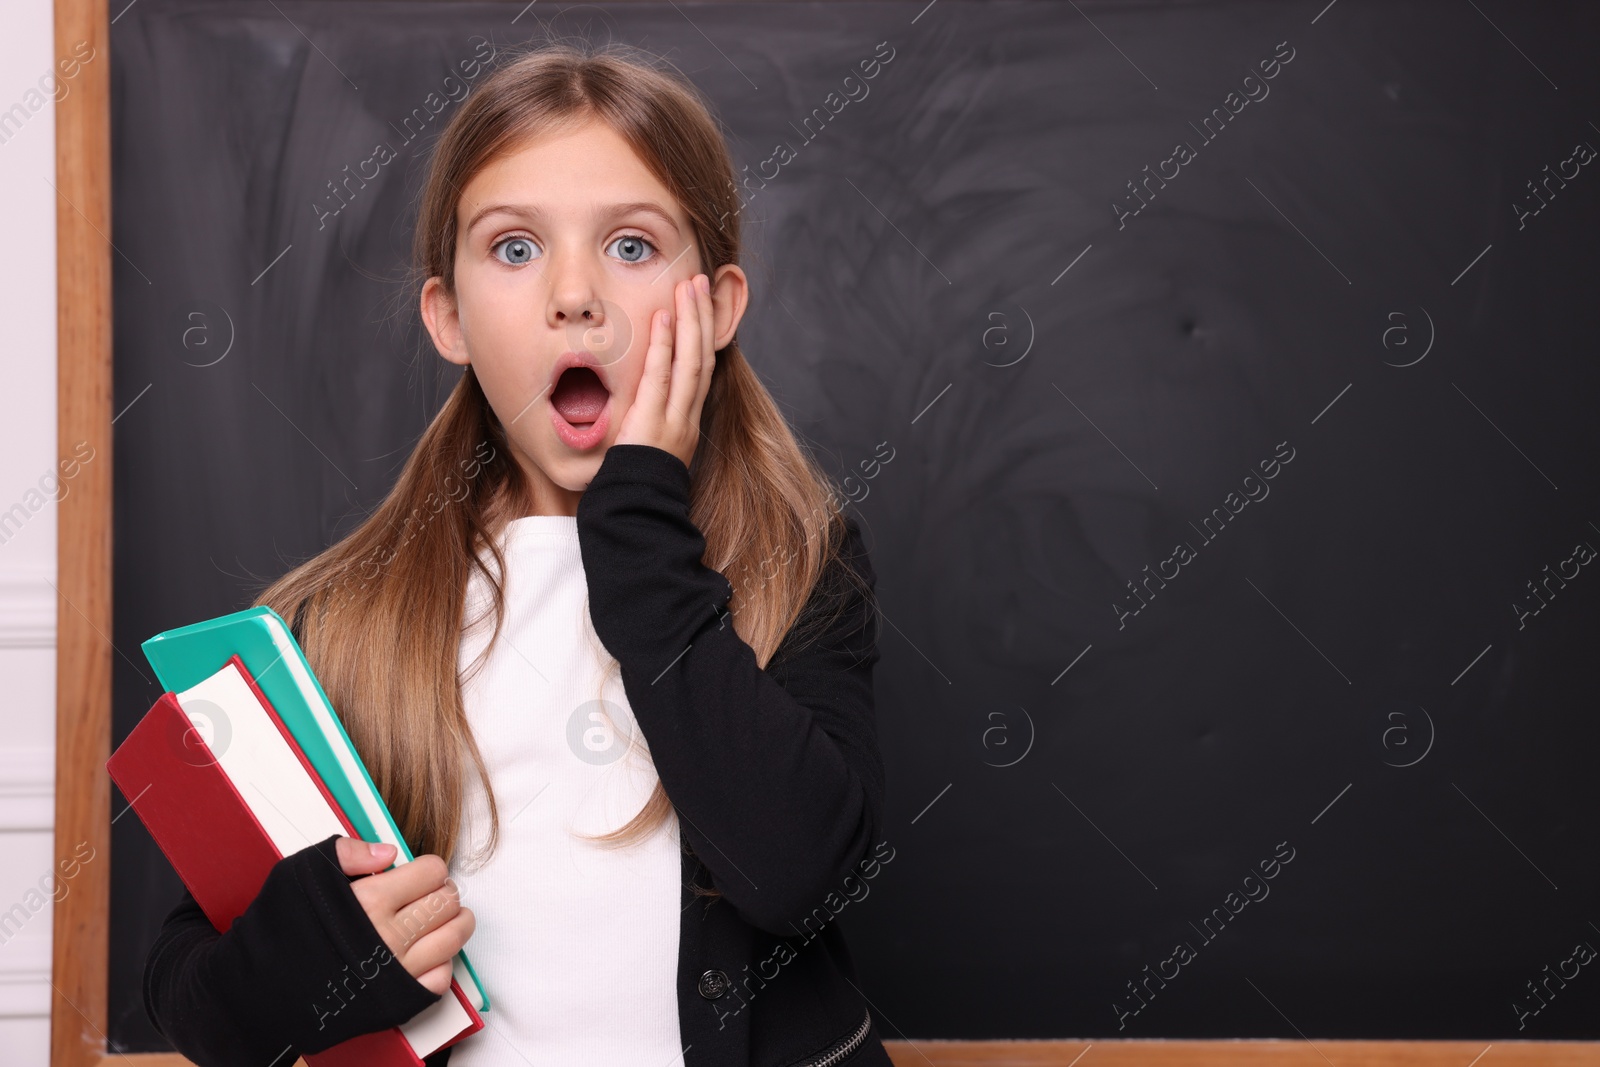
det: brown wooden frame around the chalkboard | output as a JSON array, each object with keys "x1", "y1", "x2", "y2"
[{"x1": 50, "y1": 0, "x2": 1600, "y2": 1067}]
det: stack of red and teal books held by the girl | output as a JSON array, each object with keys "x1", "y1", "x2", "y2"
[{"x1": 106, "y1": 608, "x2": 490, "y2": 1067}]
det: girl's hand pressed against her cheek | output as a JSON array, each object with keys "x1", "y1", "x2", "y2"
[{"x1": 613, "y1": 274, "x2": 717, "y2": 467}]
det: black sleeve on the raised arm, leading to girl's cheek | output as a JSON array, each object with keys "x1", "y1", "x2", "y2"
[{"x1": 578, "y1": 445, "x2": 885, "y2": 936}]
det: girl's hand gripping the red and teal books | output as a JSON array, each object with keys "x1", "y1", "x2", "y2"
[{"x1": 336, "y1": 837, "x2": 477, "y2": 993}]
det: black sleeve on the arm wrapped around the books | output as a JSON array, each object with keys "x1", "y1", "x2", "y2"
[{"x1": 144, "y1": 835, "x2": 438, "y2": 1067}]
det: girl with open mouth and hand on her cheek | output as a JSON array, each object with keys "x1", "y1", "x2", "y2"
[{"x1": 144, "y1": 35, "x2": 893, "y2": 1067}]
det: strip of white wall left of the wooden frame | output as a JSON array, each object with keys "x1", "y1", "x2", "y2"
[{"x1": 0, "y1": 0, "x2": 70, "y2": 1067}]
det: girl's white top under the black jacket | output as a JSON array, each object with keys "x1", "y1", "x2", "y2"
[{"x1": 450, "y1": 515, "x2": 683, "y2": 1067}]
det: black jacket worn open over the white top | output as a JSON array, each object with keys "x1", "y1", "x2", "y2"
[{"x1": 144, "y1": 445, "x2": 894, "y2": 1067}]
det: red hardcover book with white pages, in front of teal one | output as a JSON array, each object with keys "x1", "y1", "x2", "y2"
[{"x1": 106, "y1": 656, "x2": 483, "y2": 1067}]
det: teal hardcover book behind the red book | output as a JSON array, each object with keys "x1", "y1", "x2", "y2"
[{"x1": 142, "y1": 608, "x2": 490, "y2": 1011}]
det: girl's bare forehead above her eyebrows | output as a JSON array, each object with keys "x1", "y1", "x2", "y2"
[{"x1": 456, "y1": 120, "x2": 688, "y2": 229}]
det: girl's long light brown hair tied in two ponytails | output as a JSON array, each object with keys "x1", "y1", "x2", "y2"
[{"x1": 256, "y1": 43, "x2": 870, "y2": 896}]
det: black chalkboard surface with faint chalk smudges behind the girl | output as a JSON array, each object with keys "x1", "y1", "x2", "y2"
[{"x1": 110, "y1": 0, "x2": 1600, "y2": 1051}]
